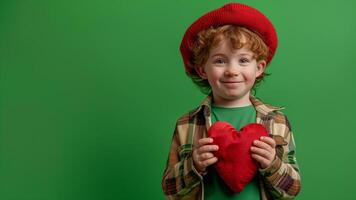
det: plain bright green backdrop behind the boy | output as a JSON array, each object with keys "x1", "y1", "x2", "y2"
[{"x1": 0, "y1": 0, "x2": 356, "y2": 200}]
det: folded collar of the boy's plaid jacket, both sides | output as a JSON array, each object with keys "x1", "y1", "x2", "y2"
[{"x1": 192, "y1": 93, "x2": 284, "y2": 117}]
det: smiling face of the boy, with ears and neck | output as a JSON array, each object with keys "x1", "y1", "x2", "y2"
[{"x1": 197, "y1": 40, "x2": 266, "y2": 106}]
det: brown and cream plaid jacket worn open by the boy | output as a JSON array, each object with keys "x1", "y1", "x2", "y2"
[{"x1": 162, "y1": 95, "x2": 301, "y2": 200}]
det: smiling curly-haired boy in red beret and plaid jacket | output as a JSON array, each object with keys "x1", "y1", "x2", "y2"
[{"x1": 162, "y1": 3, "x2": 300, "y2": 200}]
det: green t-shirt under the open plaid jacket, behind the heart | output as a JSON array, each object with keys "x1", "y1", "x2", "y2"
[{"x1": 204, "y1": 104, "x2": 260, "y2": 200}]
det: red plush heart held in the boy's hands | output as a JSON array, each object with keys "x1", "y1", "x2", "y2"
[{"x1": 208, "y1": 121, "x2": 268, "y2": 192}]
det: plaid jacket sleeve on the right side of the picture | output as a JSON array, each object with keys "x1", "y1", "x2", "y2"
[{"x1": 260, "y1": 118, "x2": 301, "y2": 199}]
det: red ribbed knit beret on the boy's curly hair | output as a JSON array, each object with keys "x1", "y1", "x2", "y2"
[{"x1": 180, "y1": 3, "x2": 278, "y2": 74}]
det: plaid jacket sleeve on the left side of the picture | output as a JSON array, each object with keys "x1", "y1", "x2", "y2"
[{"x1": 162, "y1": 125, "x2": 202, "y2": 199}]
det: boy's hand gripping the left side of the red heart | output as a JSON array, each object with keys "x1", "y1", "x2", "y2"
[{"x1": 193, "y1": 138, "x2": 219, "y2": 173}]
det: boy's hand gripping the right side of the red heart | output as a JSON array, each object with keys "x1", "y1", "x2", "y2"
[{"x1": 251, "y1": 136, "x2": 276, "y2": 169}]
